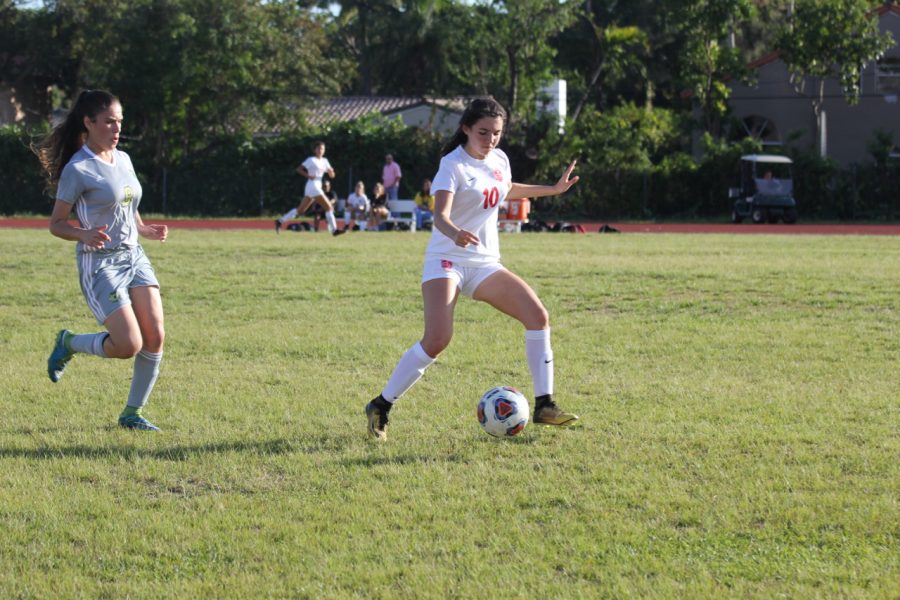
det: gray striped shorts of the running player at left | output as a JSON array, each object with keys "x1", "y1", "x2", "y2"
[{"x1": 77, "y1": 246, "x2": 159, "y2": 325}]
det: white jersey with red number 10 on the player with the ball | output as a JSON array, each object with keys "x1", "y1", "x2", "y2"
[{"x1": 425, "y1": 146, "x2": 512, "y2": 266}]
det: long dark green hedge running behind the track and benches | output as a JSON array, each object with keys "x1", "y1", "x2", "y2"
[{"x1": 0, "y1": 120, "x2": 900, "y2": 220}]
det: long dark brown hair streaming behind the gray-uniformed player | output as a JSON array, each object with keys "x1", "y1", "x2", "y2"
[{"x1": 31, "y1": 90, "x2": 119, "y2": 190}]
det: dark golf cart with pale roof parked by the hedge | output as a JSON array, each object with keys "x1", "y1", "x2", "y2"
[{"x1": 728, "y1": 154, "x2": 797, "y2": 224}]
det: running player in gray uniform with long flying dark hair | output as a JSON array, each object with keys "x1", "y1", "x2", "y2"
[{"x1": 35, "y1": 90, "x2": 168, "y2": 431}]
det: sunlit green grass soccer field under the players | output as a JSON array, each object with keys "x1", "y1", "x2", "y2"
[{"x1": 0, "y1": 230, "x2": 900, "y2": 598}]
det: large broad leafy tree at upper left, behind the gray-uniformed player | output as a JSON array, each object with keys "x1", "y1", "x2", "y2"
[{"x1": 34, "y1": 0, "x2": 350, "y2": 164}]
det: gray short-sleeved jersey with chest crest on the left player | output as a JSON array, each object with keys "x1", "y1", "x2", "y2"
[{"x1": 56, "y1": 146, "x2": 142, "y2": 252}]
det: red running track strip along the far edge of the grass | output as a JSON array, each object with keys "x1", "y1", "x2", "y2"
[{"x1": 0, "y1": 219, "x2": 900, "y2": 235}]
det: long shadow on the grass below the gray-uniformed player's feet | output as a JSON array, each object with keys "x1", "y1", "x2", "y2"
[{"x1": 0, "y1": 437, "x2": 345, "y2": 461}]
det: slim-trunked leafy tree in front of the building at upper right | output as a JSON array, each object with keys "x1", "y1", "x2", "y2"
[{"x1": 779, "y1": 0, "x2": 894, "y2": 156}]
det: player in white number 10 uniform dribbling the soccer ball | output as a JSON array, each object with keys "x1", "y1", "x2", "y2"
[{"x1": 365, "y1": 99, "x2": 578, "y2": 440}]
